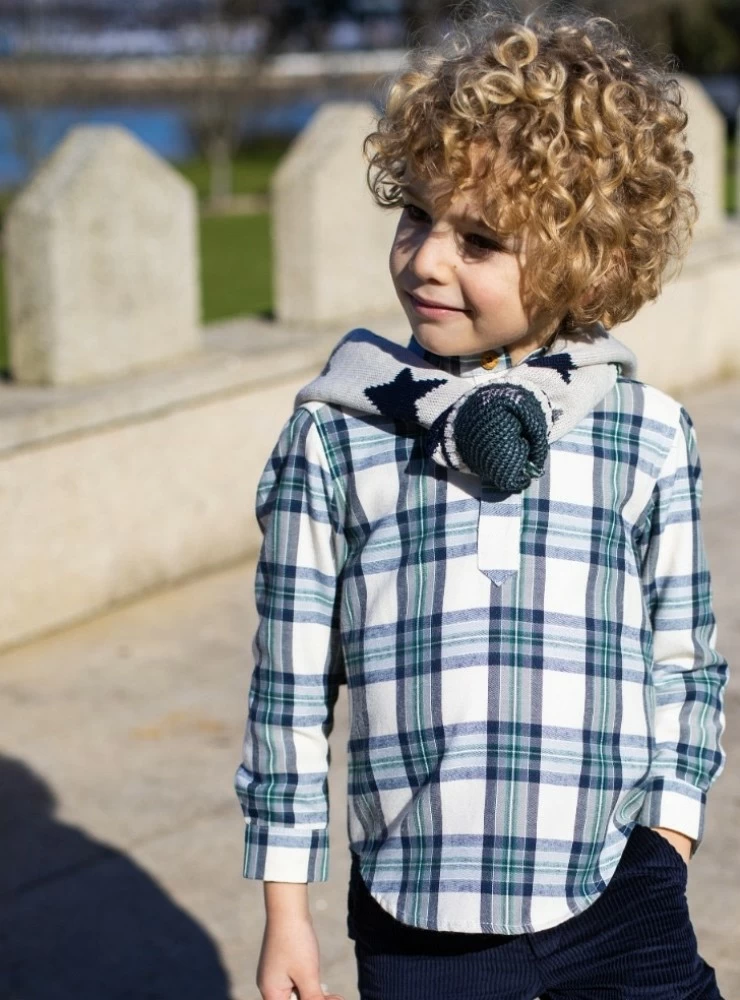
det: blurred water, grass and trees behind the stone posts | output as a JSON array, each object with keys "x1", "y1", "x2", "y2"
[{"x1": 0, "y1": 0, "x2": 740, "y2": 371}]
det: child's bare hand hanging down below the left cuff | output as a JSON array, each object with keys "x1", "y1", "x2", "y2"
[{"x1": 257, "y1": 914, "x2": 344, "y2": 1000}]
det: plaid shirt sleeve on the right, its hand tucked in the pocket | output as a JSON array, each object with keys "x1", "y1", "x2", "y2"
[{"x1": 637, "y1": 407, "x2": 728, "y2": 855}]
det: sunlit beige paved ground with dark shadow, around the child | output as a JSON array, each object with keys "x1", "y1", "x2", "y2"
[{"x1": 0, "y1": 381, "x2": 740, "y2": 1000}]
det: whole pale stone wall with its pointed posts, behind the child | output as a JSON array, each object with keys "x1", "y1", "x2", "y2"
[{"x1": 0, "y1": 82, "x2": 740, "y2": 649}]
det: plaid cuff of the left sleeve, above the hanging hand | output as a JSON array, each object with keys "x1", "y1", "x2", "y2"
[{"x1": 244, "y1": 820, "x2": 329, "y2": 882}]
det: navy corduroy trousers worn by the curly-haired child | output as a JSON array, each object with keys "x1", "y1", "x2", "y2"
[{"x1": 347, "y1": 825, "x2": 722, "y2": 1000}]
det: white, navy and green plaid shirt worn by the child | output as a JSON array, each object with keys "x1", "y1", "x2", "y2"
[{"x1": 236, "y1": 341, "x2": 727, "y2": 934}]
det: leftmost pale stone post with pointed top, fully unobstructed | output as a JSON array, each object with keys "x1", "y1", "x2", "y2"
[{"x1": 5, "y1": 126, "x2": 200, "y2": 385}]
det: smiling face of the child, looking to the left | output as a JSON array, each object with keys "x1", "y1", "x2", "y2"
[{"x1": 389, "y1": 166, "x2": 562, "y2": 362}]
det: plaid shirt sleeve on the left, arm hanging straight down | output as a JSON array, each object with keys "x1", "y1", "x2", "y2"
[{"x1": 236, "y1": 408, "x2": 344, "y2": 882}]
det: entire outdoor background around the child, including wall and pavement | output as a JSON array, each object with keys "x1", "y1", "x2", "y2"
[{"x1": 0, "y1": 0, "x2": 740, "y2": 1000}]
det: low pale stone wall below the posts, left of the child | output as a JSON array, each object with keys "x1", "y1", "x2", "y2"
[{"x1": 0, "y1": 316, "x2": 405, "y2": 649}]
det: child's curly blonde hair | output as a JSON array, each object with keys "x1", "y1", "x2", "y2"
[{"x1": 363, "y1": 3, "x2": 697, "y2": 332}]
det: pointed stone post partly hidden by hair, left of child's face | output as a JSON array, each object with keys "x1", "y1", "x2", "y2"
[{"x1": 270, "y1": 102, "x2": 401, "y2": 327}]
